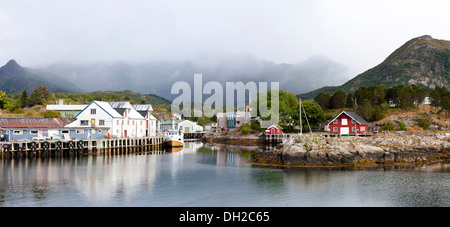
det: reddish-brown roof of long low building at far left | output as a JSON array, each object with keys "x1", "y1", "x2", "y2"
[{"x1": 0, "y1": 118, "x2": 75, "y2": 128}]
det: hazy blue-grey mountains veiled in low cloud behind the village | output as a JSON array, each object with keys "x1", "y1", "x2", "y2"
[{"x1": 40, "y1": 55, "x2": 350, "y2": 99}]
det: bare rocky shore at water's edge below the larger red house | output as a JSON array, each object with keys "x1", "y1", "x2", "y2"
[{"x1": 252, "y1": 133, "x2": 450, "y2": 167}]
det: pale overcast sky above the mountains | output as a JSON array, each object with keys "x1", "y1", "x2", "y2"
[{"x1": 0, "y1": 0, "x2": 450, "y2": 76}]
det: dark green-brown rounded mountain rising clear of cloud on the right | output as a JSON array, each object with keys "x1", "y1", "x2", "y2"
[{"x1": 297, "y1": 35, "x2": 450, "y2": 99}]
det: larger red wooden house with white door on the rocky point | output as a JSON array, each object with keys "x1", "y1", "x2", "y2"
[{"x1": 327, "y1": 111, "x2": 369, "y2": 135}]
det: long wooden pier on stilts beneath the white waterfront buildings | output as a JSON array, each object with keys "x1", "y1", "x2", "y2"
[{"x1": 0, "y1": 136, "x2": 164, "y2": 158}]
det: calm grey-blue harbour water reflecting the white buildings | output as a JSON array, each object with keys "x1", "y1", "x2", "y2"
[{"x1": 0, "y1": 142, "x2": 450, "y2": 207}]
